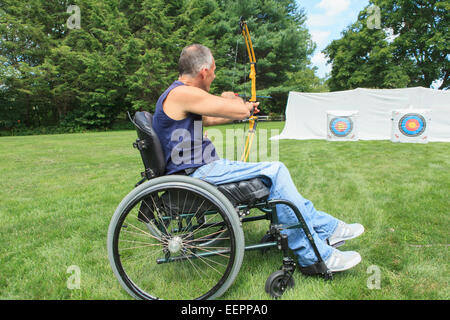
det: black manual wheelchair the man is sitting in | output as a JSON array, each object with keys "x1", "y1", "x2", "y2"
[{"x1": 107, "y1": 112, "x2": 332, "y2": 300}]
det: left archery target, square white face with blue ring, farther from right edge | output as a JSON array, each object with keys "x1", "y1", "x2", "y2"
[{"x1": 327, "y1": 111, "x2": 358, "y2": 141}]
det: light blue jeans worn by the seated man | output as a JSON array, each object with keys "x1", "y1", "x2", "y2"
[{"x1": 191, "y1": 159, "x2": 339, "y2": 267}]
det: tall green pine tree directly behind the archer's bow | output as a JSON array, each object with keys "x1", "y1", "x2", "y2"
[{"x1": 210, "y1": 0, "x2": 315, "y2": 113}]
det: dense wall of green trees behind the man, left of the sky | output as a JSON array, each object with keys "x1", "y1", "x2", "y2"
[{"x1": 0, "y1": 0, "x2": 324, "y2": 130}]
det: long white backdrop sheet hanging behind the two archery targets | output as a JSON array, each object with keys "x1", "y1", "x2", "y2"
[{"x1": 272, "y1": 87, "x2": 450, "y2": 142}]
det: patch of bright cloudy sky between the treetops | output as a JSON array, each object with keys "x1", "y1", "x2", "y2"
[{"x1": 297, "y1": 0, "x2": 369, "y2": 78}]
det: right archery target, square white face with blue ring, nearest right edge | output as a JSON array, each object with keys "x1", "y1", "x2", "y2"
[{"x1": 391, "y1": 109, "x2": 431, "y2": 143}]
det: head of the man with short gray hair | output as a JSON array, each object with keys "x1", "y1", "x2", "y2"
[{"x1": 178, "y1": 44, "x2": 213, "y2": 77}]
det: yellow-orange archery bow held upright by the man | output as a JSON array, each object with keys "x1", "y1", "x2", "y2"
[{"x1": 239, "y1": 17, "x2": 258, "y2": 162}]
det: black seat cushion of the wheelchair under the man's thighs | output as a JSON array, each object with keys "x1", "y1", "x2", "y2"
[{"x1": 218, "y1": 178, "x2": 270, "y2": 206}]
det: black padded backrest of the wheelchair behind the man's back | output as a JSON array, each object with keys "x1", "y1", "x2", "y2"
[{"x1": 132, "y1": 111, "x2": 166, "y2": 179}]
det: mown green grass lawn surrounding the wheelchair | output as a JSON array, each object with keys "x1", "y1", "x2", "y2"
[{"x1": 0, "y1": 123, "x2": 450, "y2": 299}]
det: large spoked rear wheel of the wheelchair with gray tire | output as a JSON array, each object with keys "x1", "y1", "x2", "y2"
[{"x1": 107, "y1": 176, "x2": 245, "y2": 300}]
